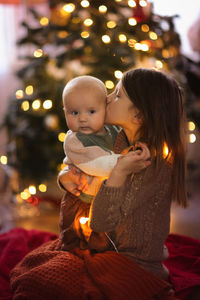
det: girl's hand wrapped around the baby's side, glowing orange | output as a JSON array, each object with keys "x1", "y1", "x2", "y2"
[{"x1": 58, "y1": 167, "x2": 88, "y2": 196}]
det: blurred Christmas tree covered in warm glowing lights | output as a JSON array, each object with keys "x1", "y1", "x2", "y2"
[{"x1": 2, "y1": 0, "x2": 198, "y2": 202}]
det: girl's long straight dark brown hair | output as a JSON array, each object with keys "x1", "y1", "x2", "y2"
[{"x1": 122, "y1": 68, "x2": 187, "y2": 207}]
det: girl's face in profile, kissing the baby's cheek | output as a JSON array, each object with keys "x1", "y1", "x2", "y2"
[{"x1": 105, "y1": 81, "x2": 141, "y2": 132}]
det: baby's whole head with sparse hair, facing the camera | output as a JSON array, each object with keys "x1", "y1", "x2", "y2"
[{"x1": 63, "y1": 76, "x2": 107, "y2": 134}]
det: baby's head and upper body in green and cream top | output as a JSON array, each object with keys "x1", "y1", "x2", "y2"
[{"x1": 60, "y1": 76, "x2": 120, "y2": 203}]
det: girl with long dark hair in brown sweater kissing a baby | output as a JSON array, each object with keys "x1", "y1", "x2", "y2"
[{"x1": 11, "y1": 69, "x2": 187, "y2": 300}]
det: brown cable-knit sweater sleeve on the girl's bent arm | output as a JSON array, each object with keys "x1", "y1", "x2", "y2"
[{"x1": 89, "y1": 159, "x2": 171, "y2": 232}]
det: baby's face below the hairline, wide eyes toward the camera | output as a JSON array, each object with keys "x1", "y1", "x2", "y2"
[{"x1": 64, "y1": 87, "x2": 106, "y2": 134}]
